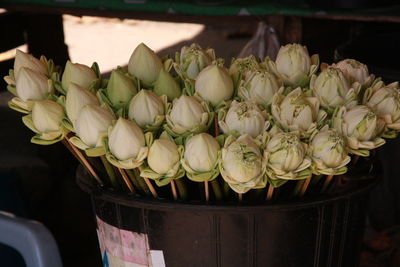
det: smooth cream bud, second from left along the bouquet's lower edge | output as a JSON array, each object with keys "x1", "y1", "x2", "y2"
[{"x1": 75, "y1": 104, "x2": 115, "y2": 148}]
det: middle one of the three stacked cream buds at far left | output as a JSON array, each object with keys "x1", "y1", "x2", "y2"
[{"x1": 15, "y1": 67, "x2": 53, "y2": 101}]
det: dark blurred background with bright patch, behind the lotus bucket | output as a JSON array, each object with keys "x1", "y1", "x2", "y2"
[{"x1": 0, "y1": 0, "x2": 400, "y2": 267}]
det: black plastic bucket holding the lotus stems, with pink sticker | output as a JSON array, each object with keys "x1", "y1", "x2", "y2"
[{"x1": 78, "y1": 166, "x2": 375, "y2": 267}]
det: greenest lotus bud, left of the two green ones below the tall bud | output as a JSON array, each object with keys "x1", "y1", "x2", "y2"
[{"x1": 106, "y1": 70, "x2": 137, "y2": 109}]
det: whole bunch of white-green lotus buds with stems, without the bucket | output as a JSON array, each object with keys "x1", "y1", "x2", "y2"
[{"x1": 4, "y1": 44, "x2": 400, "y2": 202}]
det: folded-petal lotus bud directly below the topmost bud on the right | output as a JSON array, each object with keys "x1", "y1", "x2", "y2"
[{"x1": 271, "y1": 88, "x2": 326, "y2": 137}]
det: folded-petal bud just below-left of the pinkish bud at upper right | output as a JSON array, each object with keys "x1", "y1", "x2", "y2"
[{"x1": 310, "y1": 67, "x2": 357, "y2": 112}]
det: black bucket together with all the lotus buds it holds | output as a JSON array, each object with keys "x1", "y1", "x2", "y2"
[{"x1": 4, "y1": 44, "x2": 394, "y2": 267}]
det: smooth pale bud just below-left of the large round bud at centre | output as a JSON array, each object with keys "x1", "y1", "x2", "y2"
[{"x1": 170, "y1": 95, "x2": 206, "y2": 130}]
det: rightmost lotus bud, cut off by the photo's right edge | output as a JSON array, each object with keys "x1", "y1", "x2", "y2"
[{"x1": 366, "y1": 86, "x2": 400, "y2": 130}]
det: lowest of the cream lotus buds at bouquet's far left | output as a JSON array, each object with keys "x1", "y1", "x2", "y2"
[{"x1": 32, "y1": 100, "x2": 64, "y2": 132}]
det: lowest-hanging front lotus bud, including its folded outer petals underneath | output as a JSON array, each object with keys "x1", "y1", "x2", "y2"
[{"x1": 220, "y1": 134, "x2": 265, "y2": 193}]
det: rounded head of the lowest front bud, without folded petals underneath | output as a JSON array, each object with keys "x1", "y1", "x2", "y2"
[{"x1": 221, "y1": 135, "x2": 263, "y2": 183}]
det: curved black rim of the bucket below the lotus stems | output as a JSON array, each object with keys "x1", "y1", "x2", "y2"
[{"x1": 76, "y1": 166, "x2": 379, "y2": 213}]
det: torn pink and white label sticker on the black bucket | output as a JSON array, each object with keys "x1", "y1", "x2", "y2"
[{"x1": 96, "y1": 217, "x2": 165, "y2": 267}]
